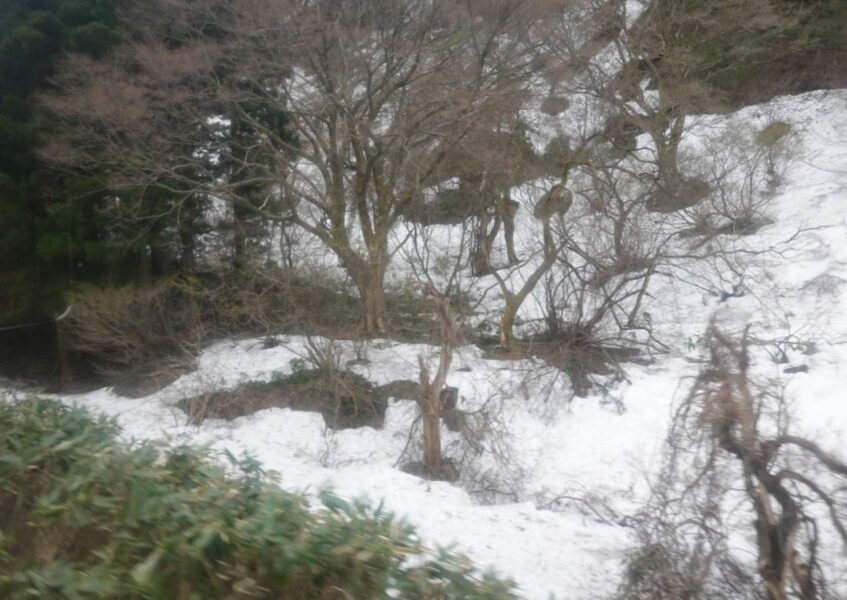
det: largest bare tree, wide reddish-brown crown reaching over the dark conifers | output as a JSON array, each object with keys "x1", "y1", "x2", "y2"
[{"x1": 44, "y1": 0, "x2": 533, "y2": 331}]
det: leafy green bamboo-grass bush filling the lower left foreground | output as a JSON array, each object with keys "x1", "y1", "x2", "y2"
[{"x1": 0, "y1": 399, "x2": 514, "y2": 600}]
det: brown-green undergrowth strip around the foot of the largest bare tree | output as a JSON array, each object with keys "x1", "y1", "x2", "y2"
[{"x1": 53, "y1": 268, "x2": 470, "y2": 398}]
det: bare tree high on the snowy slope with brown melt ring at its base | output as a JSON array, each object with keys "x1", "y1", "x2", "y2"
[{"x1": 546, "y1": 0, "x2": 720, "y2": 212}]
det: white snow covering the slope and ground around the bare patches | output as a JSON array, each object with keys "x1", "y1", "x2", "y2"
[{"x1": 1, "y1": 91, "x2": 847, "y2": 599}]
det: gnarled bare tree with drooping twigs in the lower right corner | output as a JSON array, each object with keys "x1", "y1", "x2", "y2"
[{"x1": 627, "y1": 324, "x2": 847, "y2": 600}]
